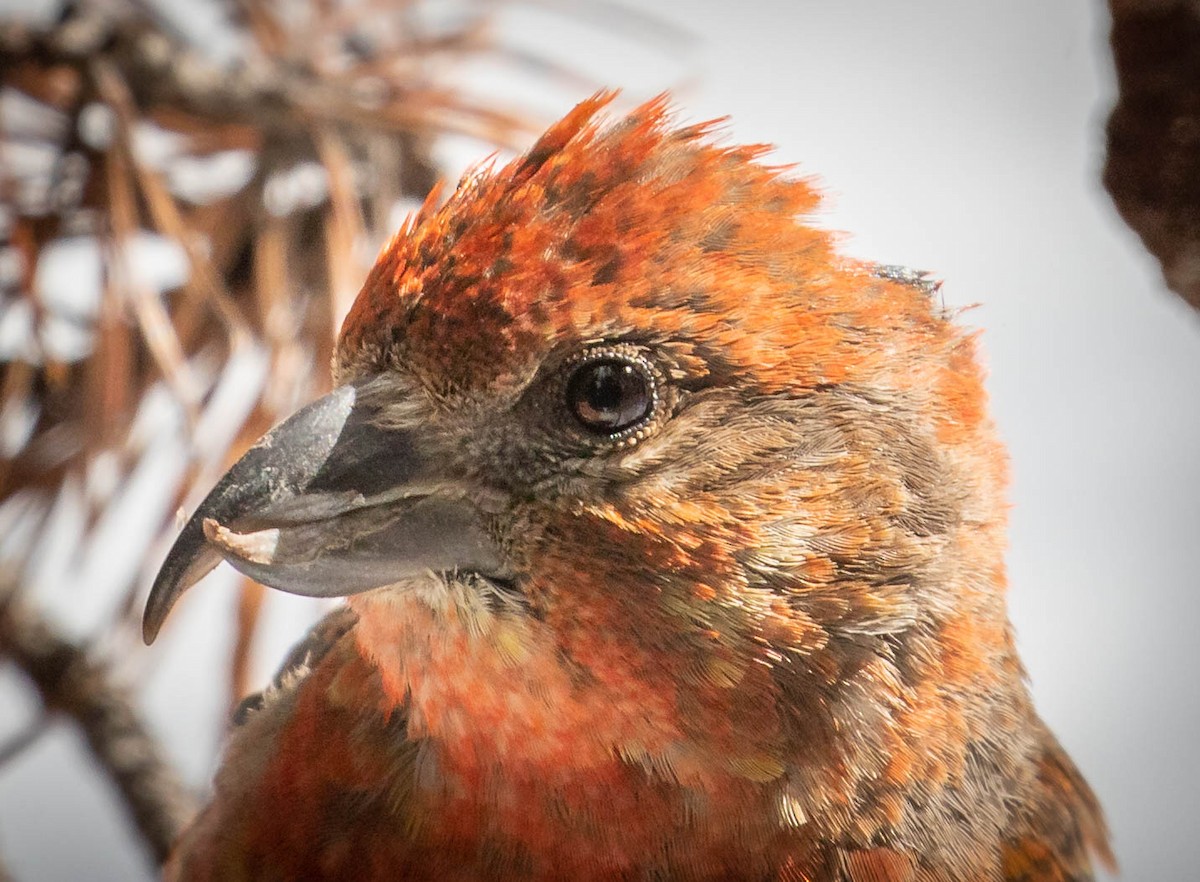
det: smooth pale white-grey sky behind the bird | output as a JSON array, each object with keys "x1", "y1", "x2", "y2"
[{"x1": 0, "y1": 0, "x2": 1200, "y2": 882}]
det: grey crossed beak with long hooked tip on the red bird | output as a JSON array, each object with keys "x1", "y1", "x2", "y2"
[{"x1": 142, "y1": 378, "x2": 504, "y2": 643}]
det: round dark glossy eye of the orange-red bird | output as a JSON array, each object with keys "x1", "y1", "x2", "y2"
[{"x1": 566, "y1": 358, "x2": 654, "y2": 434}]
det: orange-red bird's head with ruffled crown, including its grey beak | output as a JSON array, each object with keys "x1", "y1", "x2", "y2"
[{"x1": 145, "y1": 95, "x2": 1019, "y2": 801}]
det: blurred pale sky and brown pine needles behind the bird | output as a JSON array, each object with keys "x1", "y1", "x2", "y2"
[{"x1": 0, "y1": 0, "x2": 1200, "y2": 882}]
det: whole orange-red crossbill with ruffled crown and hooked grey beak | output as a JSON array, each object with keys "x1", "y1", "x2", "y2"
[{"x1": 145, "y1": 95, "x2": 1110, "y2": 882}]
